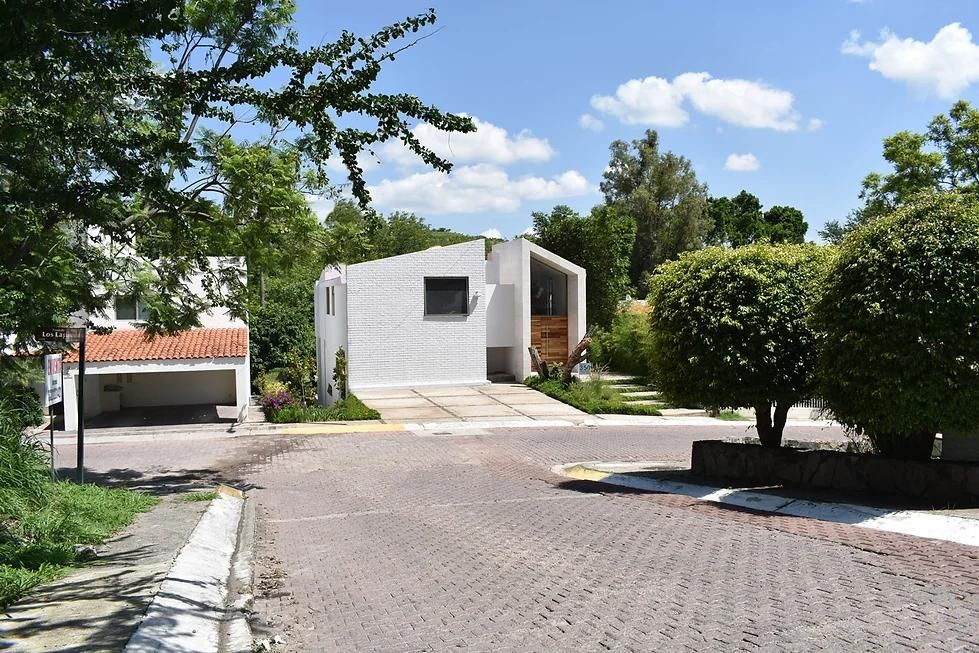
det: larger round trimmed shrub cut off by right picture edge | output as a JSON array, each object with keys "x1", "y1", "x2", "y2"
[{"x1": 814, "y1": 194, "x2": 979, "y2": 458}]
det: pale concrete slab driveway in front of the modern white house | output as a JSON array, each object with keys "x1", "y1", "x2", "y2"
[{"x1": 357, "y1": 383, "x2": 588, "y2": 424}]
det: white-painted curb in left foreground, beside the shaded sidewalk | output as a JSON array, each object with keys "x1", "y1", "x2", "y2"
[{"x1": 124, "y1": 493, "x2": 245, "y2": 653}]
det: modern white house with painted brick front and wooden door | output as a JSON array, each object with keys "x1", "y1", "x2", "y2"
[{"x1": 315, "y1": 238, "x2": 585, "y2": 404}]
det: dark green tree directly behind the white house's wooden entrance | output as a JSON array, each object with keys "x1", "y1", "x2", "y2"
[{"x1": 531, "y1": 205, "x2": 636, "y2": 327}]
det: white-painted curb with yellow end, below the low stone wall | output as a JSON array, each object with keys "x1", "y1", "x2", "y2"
[{"x1": 551, "y1": 462, "x2": 979, "y2": 547}]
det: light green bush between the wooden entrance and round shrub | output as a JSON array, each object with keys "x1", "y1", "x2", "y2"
[{"x1": 588, "y1": 302, "x2": 650, "y2": 376}]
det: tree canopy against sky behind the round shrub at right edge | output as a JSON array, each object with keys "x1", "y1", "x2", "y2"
[{"x1": 819, "y1": 100, "x2": 979, "y2": 242}]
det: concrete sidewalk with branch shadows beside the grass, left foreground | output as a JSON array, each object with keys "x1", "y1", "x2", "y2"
[{"x1": 0, "y1": 495, "x2": 208, "y2": 653}]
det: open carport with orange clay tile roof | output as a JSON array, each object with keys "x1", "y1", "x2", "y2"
[{"x1": 65, "y1": 328, "x2": 251, "y2": 431}]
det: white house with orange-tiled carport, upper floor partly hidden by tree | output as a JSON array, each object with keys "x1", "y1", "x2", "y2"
[{"x1": 64, "y1": 259, "x2": 251, "y2": 431}]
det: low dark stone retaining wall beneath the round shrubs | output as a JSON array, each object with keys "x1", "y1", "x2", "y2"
[{"x1": 691, "y1": 440, "x2": 979, "y2": 506}]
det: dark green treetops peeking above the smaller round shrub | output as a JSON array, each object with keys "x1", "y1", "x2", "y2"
[{"x1": 707, "y1": 190, "x2": 809, "y2": 247}]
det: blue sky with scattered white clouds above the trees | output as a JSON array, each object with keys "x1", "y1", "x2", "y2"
[{"x1": 297, "y1": 0, "x2": 979, "y2": 239}]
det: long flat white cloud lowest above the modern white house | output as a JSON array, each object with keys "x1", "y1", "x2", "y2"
[{"x1": 368, "y1": 163, "x2": 593, "y2": 215}]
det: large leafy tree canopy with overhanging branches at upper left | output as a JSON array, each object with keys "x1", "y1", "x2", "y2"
[{"x1": 0, "y1": 0, "x2": 474, "y2": 346}]
